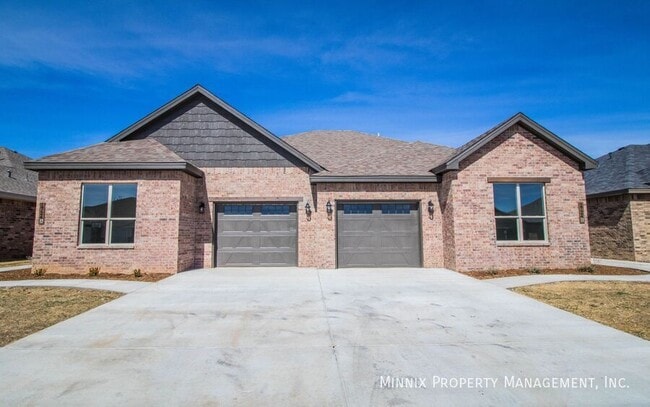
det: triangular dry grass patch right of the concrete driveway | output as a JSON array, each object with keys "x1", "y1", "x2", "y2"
[{"x1": 512, "y1": 281, "x2": 650, "y2": 340}]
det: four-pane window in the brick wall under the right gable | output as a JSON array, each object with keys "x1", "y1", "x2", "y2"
[{"x1": 494, "y1": 184, "x2": 547, "y2": 241}]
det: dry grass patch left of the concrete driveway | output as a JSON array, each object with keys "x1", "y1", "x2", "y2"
[{"x1": 0, "y1": 287, "x2": 122, "y2": 346}]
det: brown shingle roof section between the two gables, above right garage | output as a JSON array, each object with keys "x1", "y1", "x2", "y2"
[{"x1": 283, "y1": 130, "x2": 455, "y2": 181}]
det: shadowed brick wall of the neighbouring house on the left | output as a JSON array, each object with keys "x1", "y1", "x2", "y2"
[{"x1": 0, "y1": 198, "x2": 36, "y2": 261}]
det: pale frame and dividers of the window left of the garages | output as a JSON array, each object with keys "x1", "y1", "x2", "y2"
[{"x1": 77, "y1": 182, "x2": 138, "y2": 249}]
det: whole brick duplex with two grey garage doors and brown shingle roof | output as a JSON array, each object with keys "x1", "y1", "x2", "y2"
[{"x1": 28, "y1": 85, "x2": 595, "y2": 273}]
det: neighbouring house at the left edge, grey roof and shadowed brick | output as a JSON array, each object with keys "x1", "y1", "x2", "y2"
[{"x1": 0, "y1": 147, "x2": 38, "y2": 261}]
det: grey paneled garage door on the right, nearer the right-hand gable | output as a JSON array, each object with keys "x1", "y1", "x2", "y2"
[{"x1": 337, "y1": 202, "x2": 422, "y2": 267}]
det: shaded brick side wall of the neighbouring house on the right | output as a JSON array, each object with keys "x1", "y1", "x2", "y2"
[{"x1": 587, "y1": 195, "x2": 634, "y2": 261}]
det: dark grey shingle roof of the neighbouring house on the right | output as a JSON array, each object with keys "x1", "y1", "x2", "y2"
[{"x1": 585, "y1": 144, "x2": 650, "y2": 195}]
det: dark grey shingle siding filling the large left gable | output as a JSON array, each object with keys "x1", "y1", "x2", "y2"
[{"x1": 124, "y1": 95, "x2": 301, "y2": 167}]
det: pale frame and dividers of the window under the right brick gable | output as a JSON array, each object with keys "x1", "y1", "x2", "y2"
[{"x1": 492, "y1": 180, "x2": 549, "y2": 246}]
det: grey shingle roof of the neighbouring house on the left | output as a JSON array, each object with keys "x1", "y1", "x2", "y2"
[{"x1": 0, "y1": 147, "x2": 38, "y2": 201}]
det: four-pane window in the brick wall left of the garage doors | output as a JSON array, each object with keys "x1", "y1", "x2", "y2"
[{"x1": 79, "y1": 184, "x2": 137, "y2": 245}]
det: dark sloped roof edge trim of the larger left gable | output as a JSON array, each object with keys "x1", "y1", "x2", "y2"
[{"x1": 106, "y1": 85, "x2": 324, "y2": 171}]
